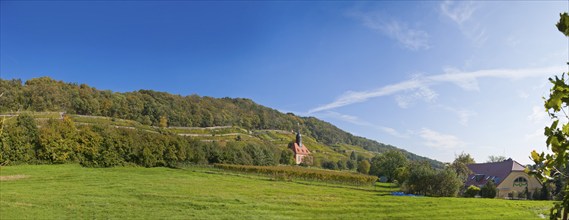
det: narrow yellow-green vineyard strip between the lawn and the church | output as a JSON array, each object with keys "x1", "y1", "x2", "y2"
[{"x1": 214, "y1": 164, "x2": 377, "y2": 186}]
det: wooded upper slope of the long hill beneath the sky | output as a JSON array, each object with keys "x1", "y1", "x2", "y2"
[{"x1": 0, "y1": 77, "x2": 442, "y2": 167}]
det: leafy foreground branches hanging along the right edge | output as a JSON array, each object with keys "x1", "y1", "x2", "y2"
[{"x1": 530, "y1": 12, "x2": 569, "y2": 220}]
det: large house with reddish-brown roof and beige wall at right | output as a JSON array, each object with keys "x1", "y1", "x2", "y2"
[{"x1": 465, "y1": 158, "x2": 542, "y2": 198}]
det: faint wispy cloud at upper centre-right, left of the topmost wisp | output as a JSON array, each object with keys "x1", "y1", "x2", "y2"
[{"x1": 349, "y1": 11, "x2": 431, "y2": 50}]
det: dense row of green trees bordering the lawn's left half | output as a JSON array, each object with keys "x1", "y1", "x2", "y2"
[{"x1": 0, "y1": 114, "x2": 294, "y2": 167}]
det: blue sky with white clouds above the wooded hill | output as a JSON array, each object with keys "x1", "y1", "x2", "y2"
[{"x1": 0, "y1": 1, "x2": 569, "y2": 163}]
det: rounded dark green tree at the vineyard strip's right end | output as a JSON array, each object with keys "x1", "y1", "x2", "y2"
[{"x1": 370, "y1": 150, "x2": 407, "y2": 182}]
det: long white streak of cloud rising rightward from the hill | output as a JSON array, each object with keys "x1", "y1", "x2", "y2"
[{"x1": 308, "y1": 66, "x2": 566, "y2": 114}]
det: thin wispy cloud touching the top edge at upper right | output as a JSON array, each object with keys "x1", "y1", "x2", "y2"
[{"x1": 440, "y1": 1, "x2": 488, "y2": 45}]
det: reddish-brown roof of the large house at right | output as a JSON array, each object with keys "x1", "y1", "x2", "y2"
[{"x1": 466, "y1": 158, "x2": 525, "y2": 186}]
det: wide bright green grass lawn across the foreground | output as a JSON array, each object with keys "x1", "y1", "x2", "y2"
[{"x1": 0, "y1": 165, "x2": 551, "y2": 219}]
